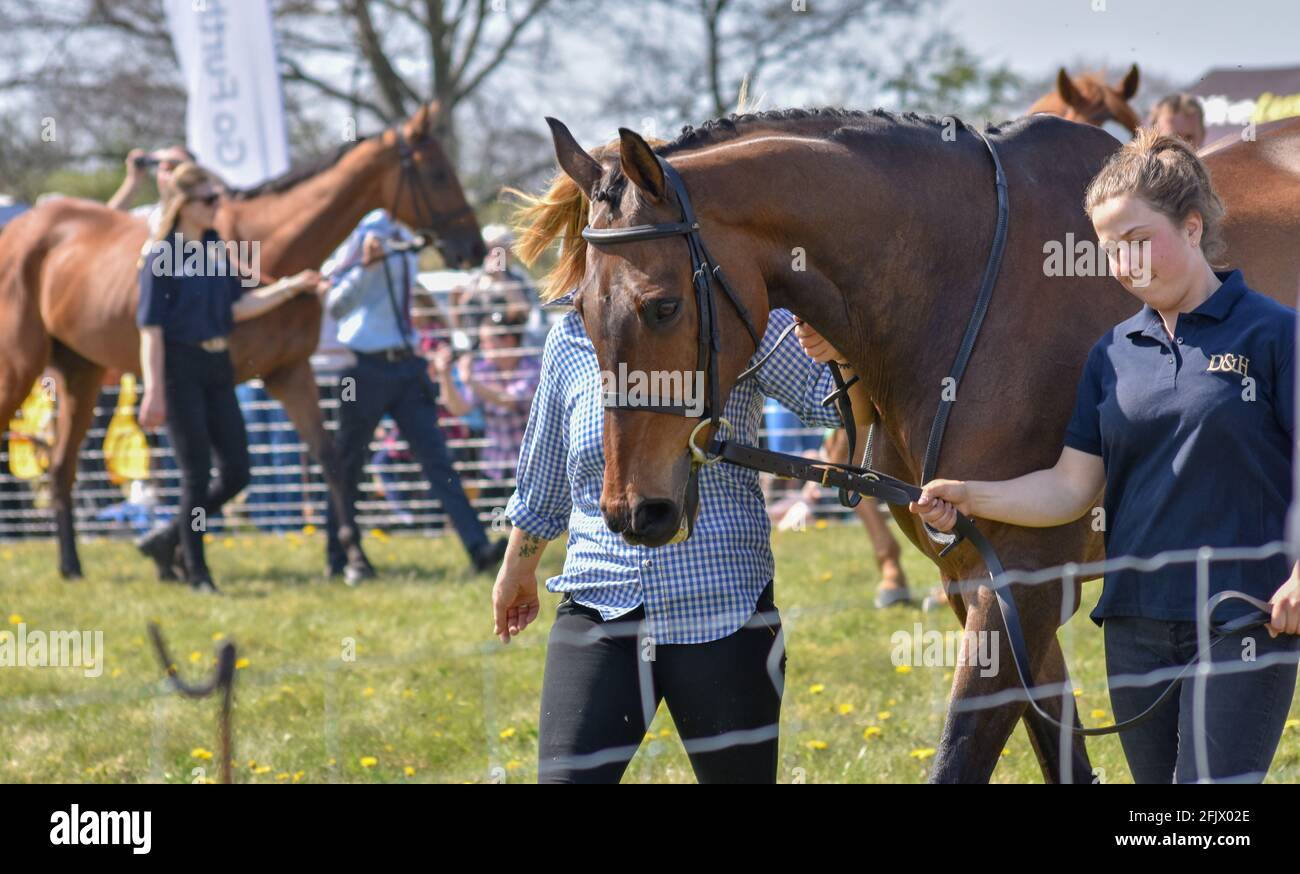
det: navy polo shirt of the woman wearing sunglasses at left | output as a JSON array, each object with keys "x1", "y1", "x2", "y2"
[{"x1": 135, "y1": 230, "x2": 243, "y2": 345}]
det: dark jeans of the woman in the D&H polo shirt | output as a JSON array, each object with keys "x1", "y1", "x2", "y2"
[{"x1": 1102, "y1": 616, "x2": 1300, "y2": 783}]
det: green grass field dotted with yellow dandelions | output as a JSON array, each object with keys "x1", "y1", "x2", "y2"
[{"x1": 0, "y1": 525, "x2": 1300, "y2": 783}]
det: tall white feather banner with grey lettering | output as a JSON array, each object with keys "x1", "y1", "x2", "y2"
[{"x1": 164, "y1": 0, "x2": 289, "y2": 187}]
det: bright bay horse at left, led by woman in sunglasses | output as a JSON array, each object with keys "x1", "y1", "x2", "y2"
[{"x1": 0, "y1": 103, "x2": 486, "y2": 579}]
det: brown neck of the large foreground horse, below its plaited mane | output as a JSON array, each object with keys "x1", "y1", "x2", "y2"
[{"x1": 688, "y1": 130, "x2": 996, "y2": 451}]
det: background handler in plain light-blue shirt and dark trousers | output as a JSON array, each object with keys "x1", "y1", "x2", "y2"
[{"x1": 325, "y1": 209, "x2": 506, "y2": 585}]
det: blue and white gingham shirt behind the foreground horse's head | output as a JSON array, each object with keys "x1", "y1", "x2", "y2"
[{"x1": 506, "y1": 310, "x2": 841, "y2": 644}]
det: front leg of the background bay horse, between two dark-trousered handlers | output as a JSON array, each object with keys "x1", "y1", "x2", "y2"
[{"x1": 263, "y1": 362, "x2": 372, "y2": 574}]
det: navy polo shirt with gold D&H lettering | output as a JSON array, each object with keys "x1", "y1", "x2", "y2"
[{"x1": 1065, "y1": 271, "x2": 1296, "y2": 624}]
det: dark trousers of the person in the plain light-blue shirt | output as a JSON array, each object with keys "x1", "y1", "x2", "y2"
[{"x1": 325, "y1": 354, "x2": 488, "y2": 571}]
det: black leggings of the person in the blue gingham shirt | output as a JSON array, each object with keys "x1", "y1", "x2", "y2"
[{"x1": 537, "y1": 583, "x2": 785, "y2": 783}]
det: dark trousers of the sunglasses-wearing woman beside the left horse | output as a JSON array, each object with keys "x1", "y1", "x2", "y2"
[{"x1": 164, "y1": 343, "x2": 248, "y2": 580}]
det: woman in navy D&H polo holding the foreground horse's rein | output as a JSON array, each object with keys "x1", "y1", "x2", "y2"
[{"x1": 911, "y1": 130, "x2": 1300, "y2": 783}]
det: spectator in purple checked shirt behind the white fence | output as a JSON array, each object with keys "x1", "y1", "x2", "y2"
[{"x1": 433, "y1": 310, "x2": 542, "y2": 498}]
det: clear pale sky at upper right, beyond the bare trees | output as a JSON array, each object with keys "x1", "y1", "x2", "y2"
[{"x1": 943, "y1": 0, "x2": 1300, "y2": 85}]
